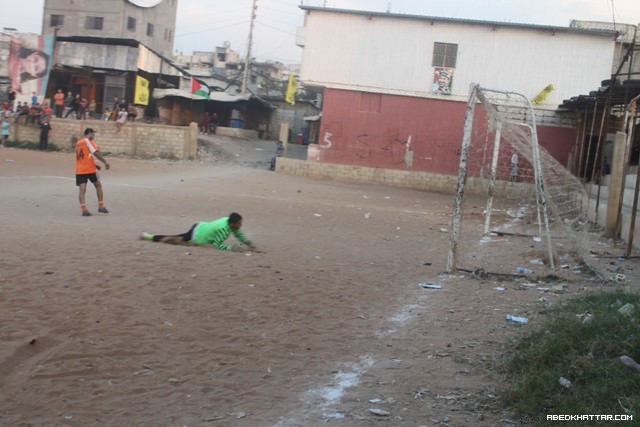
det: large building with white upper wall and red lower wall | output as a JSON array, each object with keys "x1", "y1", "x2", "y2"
[{"x1": 297, "y1": 6, "x2": 636, "y2": 175}]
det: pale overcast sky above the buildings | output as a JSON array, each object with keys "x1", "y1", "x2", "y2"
[{"x1": 0, "y1": 0, "x2": 640, "y2": 64}]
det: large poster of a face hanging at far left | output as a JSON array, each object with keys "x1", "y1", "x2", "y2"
[{"x1": 9, "y1": 34, "x2": 53, "y2": 98}]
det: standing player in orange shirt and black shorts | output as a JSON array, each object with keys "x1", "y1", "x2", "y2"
[{"x1": 76, "y1": 128, "x2": 111, "y2": 216}]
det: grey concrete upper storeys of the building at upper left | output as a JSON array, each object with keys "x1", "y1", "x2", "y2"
[{"x1": 42, "y1": 0, "x2": 178, "y2": 58}]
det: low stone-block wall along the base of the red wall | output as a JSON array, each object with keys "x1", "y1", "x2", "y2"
[{"x1": 276, "y1": 157, "x2": 534, "y2": 199}]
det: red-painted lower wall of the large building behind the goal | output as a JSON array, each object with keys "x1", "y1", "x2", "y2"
[{"x1": 318, "y1": 89, "x2": 576, "y2": 178}]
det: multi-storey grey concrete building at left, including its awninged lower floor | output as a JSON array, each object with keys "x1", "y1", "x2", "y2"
[{"x1": 36, "y1": 0, "x2": 184, "y2": 116}]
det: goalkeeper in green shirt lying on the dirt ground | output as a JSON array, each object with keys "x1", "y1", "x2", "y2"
[{"x1": 140, "y1": 212, "x2": 256, "y2": 252}]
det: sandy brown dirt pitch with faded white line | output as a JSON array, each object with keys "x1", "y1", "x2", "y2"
[{"x1": 0, "y1": 141, "x2": 632, "y2": 427}]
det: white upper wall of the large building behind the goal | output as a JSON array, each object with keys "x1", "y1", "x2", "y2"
[{"x1": 299, "y1": 10, "x2": 615, "y2": 108}]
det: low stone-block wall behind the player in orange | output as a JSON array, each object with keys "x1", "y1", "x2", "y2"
[{"x1": 10, "y1": 118, "x2": 198, "y2": 160}]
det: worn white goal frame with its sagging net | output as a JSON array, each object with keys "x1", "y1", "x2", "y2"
[{"x1": 446, "y1": 85, "x2": 597, "y2": 273}]
